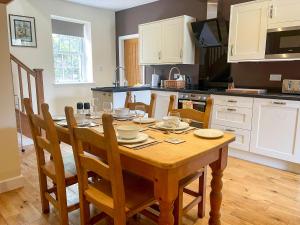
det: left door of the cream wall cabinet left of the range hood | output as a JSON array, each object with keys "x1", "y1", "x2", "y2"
[{"x1": 139, "y1": 23, "x2": 162, "y2": 64}]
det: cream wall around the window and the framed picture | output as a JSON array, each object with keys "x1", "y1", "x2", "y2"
[{"x1": 7, "y1": 0, "x2": 116, "y2": 114}]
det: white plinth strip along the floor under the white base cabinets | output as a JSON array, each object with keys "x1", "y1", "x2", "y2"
[{"x1": 229, "y1": 148, "x2": 300, "y2": 174}]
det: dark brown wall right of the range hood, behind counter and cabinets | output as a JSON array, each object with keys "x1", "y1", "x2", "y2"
[{"x1": 219, "y1": 0, "x2": 300, "y2": 89}]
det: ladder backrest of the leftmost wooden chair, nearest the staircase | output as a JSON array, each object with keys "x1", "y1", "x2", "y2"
[{"x1": 24, "y1": 98, "x2": 65, "y2": 185}]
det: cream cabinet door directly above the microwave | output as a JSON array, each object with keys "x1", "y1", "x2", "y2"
[{"x1": 268, "y1": 0, "x2": 300, "y2": 29}]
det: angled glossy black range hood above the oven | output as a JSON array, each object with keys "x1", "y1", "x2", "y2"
[{"x1": 192, "y1": 18, "x2": 229, "y2": 48}]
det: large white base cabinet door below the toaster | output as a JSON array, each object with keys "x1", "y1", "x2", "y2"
[{"x1": 250, "y1": 99, "x2": 300, "y2": 162}]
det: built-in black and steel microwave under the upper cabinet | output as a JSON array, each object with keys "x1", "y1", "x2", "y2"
[{"x1": 266, "y1": 26, "x2": 300, "y2": 59}]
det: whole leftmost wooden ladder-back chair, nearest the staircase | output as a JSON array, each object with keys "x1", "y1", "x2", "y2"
[{"x1": 24, "y1": 99, "x2": 79, "y2": 225}]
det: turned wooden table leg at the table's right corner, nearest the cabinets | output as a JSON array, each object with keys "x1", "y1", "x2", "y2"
[{"x1": 209, "y1": 148, "x2": 228, "y2": 225}]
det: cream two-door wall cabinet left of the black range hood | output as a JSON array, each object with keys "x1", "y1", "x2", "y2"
[{"x1": 139, "y1": 16, "x2": 195, "y2": 65}]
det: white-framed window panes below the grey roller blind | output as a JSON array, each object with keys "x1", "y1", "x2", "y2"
[{"x1": 52, "y1": 34, "x2": 88, "y2": 83}]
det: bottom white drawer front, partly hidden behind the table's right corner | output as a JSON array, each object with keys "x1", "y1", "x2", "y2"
[{"x1": 212, "y1": 124, "x2": 251, "y2": 152}]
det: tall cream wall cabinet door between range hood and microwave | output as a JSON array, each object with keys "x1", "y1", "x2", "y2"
[{"x1": 228, "y1": 2, "x2": 269, "y2": 62}]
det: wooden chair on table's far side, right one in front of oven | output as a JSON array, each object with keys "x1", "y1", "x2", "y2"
[{"x1": 168, "y1": 95, "x2": 212, "y2": 225}]
